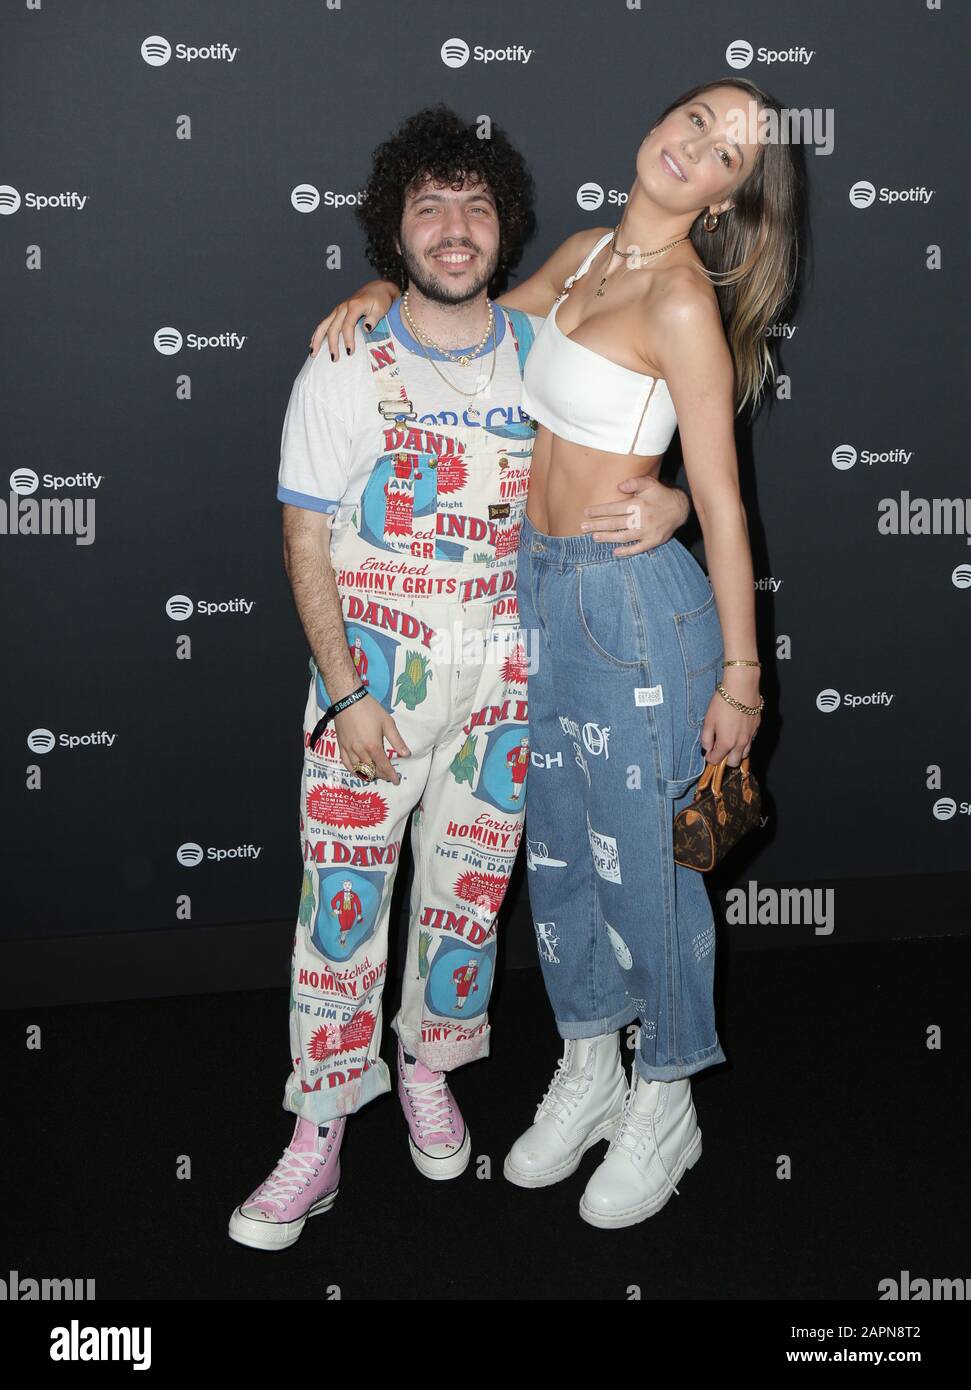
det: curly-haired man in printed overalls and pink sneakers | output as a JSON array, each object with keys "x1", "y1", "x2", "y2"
[{"x1": 229, "y1": 106, "x2": 683, "y2": 1250}]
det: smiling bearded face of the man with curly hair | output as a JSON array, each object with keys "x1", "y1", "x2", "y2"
[{"x1": 397, "y1": 178, "x2": 499, "y2": 304}]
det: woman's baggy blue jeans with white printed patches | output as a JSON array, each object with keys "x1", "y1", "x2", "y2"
[{"x1": 517, "y1": 517, "x2": 725, "y2": 1081}]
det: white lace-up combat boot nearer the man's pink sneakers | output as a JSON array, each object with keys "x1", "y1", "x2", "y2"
[{"x1": 503, "y1": 1033, "x2": 626, "y2": 1187}]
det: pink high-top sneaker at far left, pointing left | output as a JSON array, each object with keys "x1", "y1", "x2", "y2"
[{"x1": 229, "y1": 1116, "x2": 347, "y2": 1250}]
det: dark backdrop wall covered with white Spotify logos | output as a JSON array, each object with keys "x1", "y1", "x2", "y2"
[{"x1": 0, "y1": 0, "x2": 971, "y2": 1004}]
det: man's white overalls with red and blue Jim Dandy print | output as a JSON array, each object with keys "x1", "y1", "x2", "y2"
[{"x1": 283, "y1": 307, "x2": 533, "y2": 1123}]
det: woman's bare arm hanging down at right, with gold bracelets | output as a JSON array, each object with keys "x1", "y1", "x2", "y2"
[{"x1": 652, "y1": 271, "x2": 761, "y2": 767}]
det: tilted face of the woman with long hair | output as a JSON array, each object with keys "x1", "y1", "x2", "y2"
[{"x1": 638, "y1": 86, "x2": 758, "y2": 213}]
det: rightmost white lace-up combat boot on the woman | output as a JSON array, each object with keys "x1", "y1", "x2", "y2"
[{"x1": 579, "y1": 1066, "x2": 702, "y2": 1230}]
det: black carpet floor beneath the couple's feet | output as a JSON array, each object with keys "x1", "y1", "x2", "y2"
[{"x1": 0, "y1": 938, "x2": 971, "y2": 1301}]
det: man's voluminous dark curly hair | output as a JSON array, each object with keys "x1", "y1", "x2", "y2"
[{"x1": 354, "y1": 101, "x2": 536, "y2": 293}]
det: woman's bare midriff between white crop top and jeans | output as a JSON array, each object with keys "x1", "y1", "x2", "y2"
[{"x1": 526, "y1": 425, "x2": 664, "y2": 535}]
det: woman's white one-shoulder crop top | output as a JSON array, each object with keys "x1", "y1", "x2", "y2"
[{"x1": 521, "y1": 231, "x2": 678, "y2": 455}]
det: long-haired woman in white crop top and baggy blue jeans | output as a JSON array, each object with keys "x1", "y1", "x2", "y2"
[{"x1": 311, "y1": 76, "x2": 804, "y2": 1229}]
